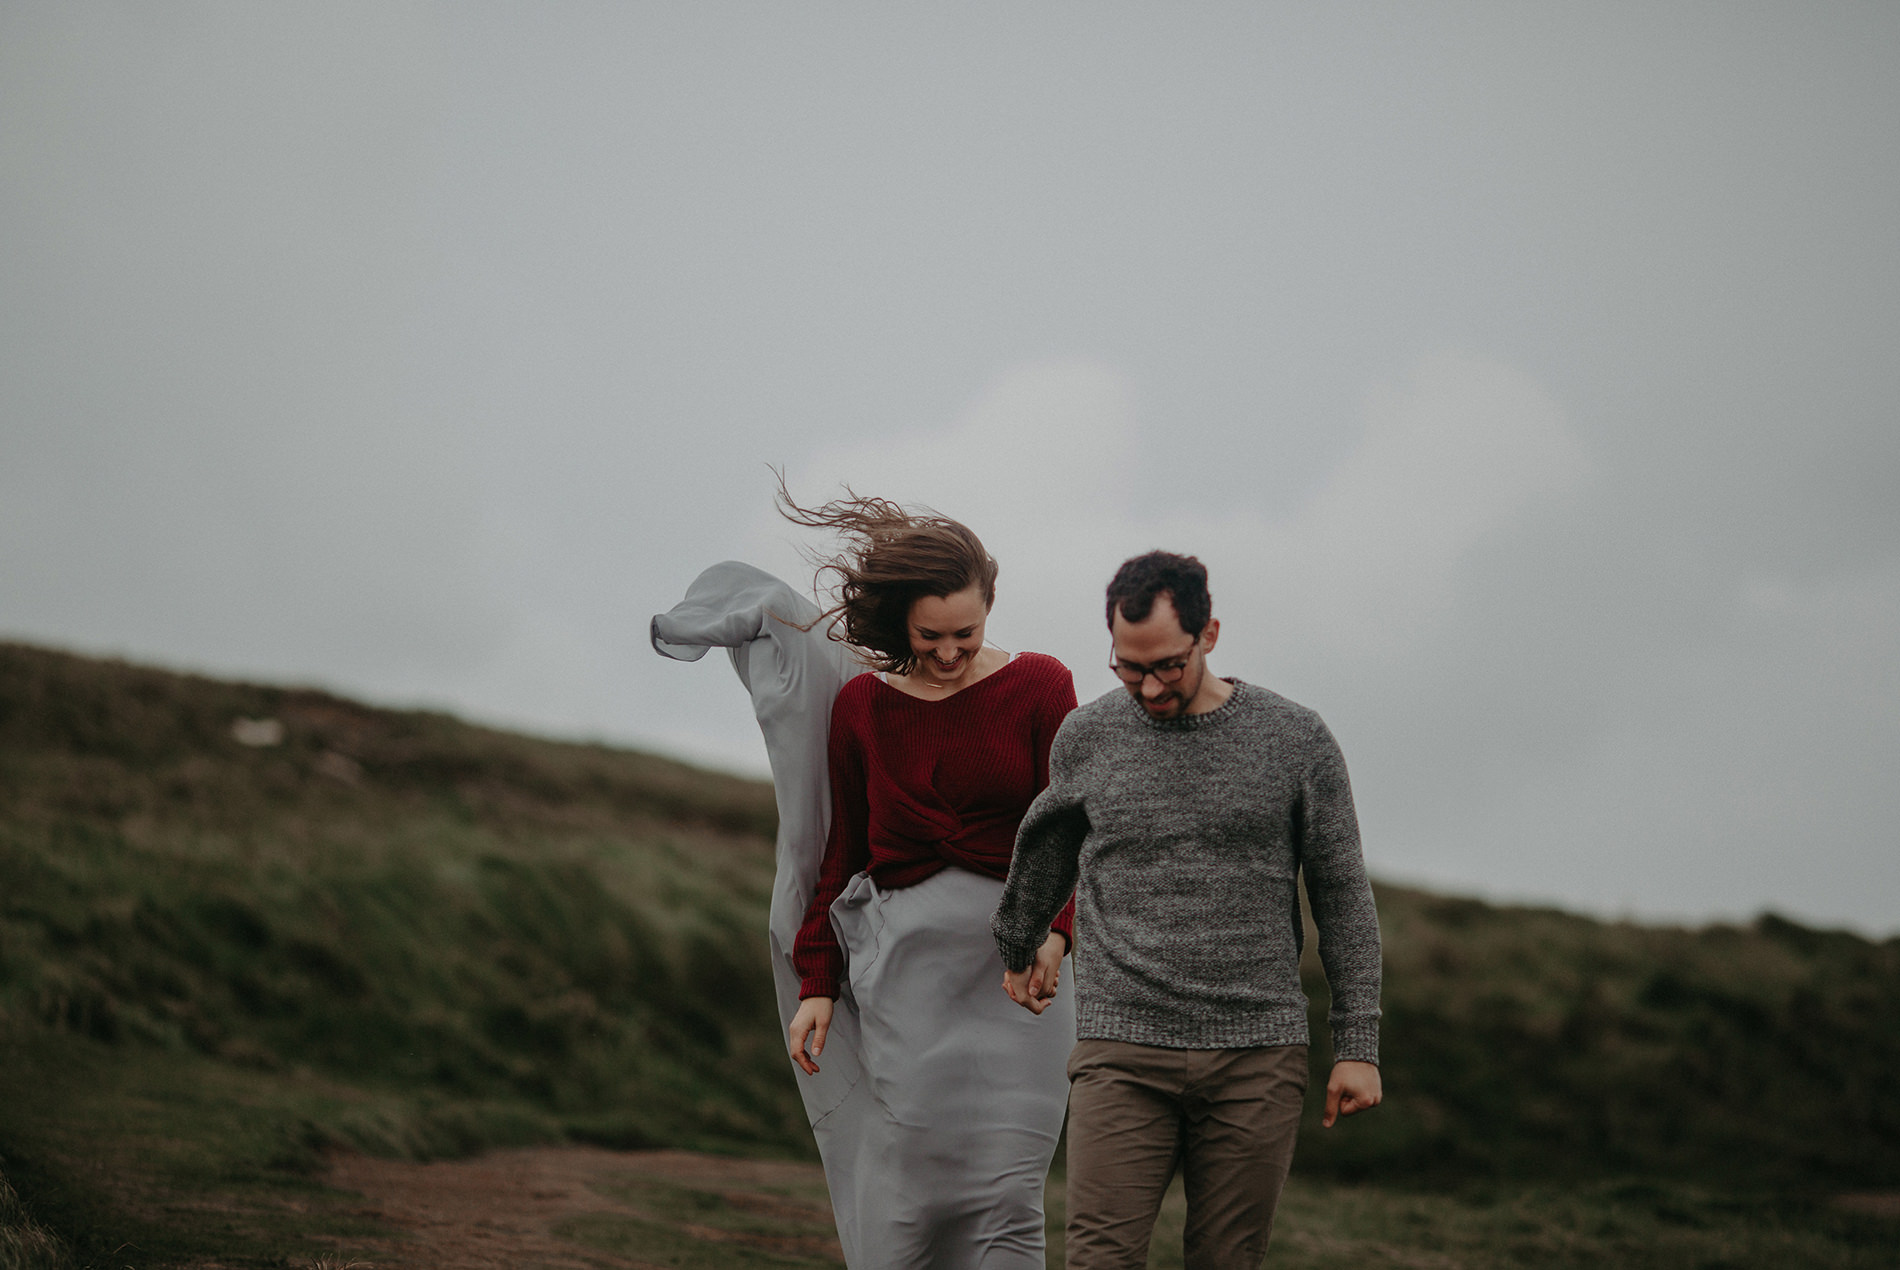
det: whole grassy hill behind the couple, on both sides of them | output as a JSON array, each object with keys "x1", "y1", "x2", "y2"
[{"x1": 0, "y1": 645, "x2": 1900, "y2": 1270}]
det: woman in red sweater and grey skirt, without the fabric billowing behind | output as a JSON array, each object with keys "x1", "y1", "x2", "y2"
[{"x1": 781, "y1": 491, "x2": 1075, "y2": 1270}]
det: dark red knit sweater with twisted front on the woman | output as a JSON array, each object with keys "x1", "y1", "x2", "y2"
[{"x1": 792, "y1": 652, "x2": 1075, "y2": 996}]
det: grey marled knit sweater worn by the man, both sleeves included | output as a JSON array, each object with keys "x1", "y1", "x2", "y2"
[{"x1": 992, "y1": 681, "x2": 1379, "y2": 1063}]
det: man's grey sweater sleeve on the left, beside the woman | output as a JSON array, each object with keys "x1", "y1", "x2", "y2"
[{"x1": 990, "y1": 715, "x2": 1089, "y2": 970}]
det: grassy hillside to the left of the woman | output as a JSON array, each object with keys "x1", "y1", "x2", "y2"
[{"x1": 0, "y1": 646, "x2": 811, "y2": 1268}]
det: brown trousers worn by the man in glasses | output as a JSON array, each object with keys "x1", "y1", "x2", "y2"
[{"x1": 1068, "y1": 1040, "x2": 1307, "y2": 1270}]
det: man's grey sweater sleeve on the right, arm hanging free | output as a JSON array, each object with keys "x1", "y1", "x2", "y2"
[{"x1": 1300, "y1": 717, "x2": 1379, "y2": 1063}]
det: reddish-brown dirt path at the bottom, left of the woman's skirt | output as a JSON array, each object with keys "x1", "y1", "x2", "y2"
[{"x1": 317, "y1": 1146, "x2": 844, "y2": 1270}]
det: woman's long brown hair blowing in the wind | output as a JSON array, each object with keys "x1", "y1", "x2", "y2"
[{"x1": 777, "y1": 475, "x2": 996, "y2": 675}]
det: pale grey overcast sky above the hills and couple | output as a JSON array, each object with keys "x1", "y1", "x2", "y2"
[{"x1": 0, "y1": 0, "x2": 1900, "y2": 933}]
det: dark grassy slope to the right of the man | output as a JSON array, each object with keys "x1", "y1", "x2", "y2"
[{"x1": 1300, "y1": 888, "x2": 1900, "y2": 1190}]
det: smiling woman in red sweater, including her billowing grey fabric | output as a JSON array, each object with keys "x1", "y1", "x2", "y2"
[{"x1": 654, "y1": 487, "x2": 1075, "y2": 1270}]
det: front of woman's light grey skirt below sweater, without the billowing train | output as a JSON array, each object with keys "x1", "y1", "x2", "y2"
[{"x1": 813, "y1": 869, "x2": 1075, "y2": 1270}]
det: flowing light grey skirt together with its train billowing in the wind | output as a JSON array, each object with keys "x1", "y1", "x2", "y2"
[{"x1": 652, "y1": 561, "x2": 1075, "y2": 1270}]
